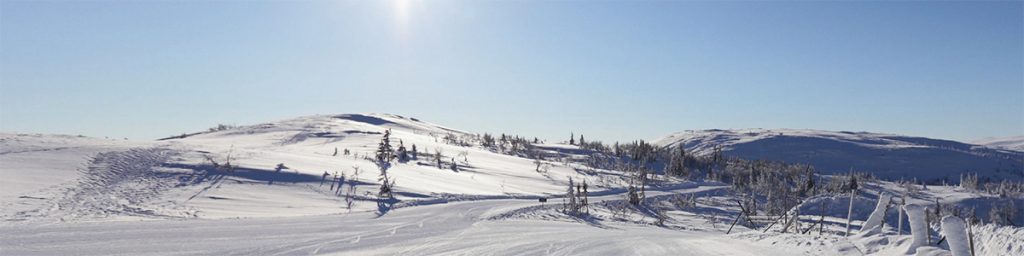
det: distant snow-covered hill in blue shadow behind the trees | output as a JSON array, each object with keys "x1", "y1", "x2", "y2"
[{"x1": 655, "y1": 129, "x2": 1024, "y2": 181}]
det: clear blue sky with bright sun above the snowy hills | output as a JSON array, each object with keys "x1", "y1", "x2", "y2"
[{"x1": 0, "y1": 0, "x2": 1024, "y2": 141}]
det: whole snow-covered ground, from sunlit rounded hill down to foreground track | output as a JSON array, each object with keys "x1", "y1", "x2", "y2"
[{"x1": 0, "y1": 114, "x2": 1024, "y2": 255}]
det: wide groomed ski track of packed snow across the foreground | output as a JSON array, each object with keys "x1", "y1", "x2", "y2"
[{"x1": 0, "y1": 200, "x2": 792, "y2": 255}]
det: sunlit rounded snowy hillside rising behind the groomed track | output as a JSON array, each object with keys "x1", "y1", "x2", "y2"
[{"x1": 0, "y1": 114, "x2": 617, "y2": 220}]
